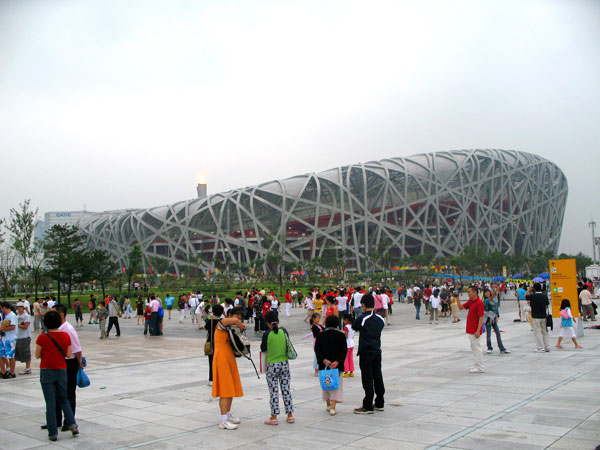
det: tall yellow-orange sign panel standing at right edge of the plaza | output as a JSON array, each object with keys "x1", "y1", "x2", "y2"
[{"x1": 549, "y1": 259, "x2": 579, "y2": 317}]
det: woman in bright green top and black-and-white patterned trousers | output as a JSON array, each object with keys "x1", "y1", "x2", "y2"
[{"x1": 260, "y1": 311, "x2": 296, "y2": 425}]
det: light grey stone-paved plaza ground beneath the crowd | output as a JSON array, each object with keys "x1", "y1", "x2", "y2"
[{"x1": 0, "y1": 300, "x2": 600, "y2": 450}]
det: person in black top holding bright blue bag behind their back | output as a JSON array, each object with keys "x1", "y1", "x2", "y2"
[{"x1": 315, "y1": 316, "x2": 348, "y2": 416}]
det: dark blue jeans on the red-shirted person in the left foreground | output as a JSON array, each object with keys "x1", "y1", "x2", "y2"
[{"x1": 40, "y1": 369, "x2": 77, "y2": 437}]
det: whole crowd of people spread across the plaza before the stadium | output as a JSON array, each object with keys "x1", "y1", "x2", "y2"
[{"x1": 0, "y1": 279, "x2": 598, "y2": 440}]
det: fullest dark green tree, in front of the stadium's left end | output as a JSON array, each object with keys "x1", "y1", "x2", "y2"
[{"x1": 43, "y1": 225, "x2": 90, "y2": 304}]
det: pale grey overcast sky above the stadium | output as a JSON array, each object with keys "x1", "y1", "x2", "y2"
[{"x1": 0, "y1": 0, "x2": 600, "y2": 254}]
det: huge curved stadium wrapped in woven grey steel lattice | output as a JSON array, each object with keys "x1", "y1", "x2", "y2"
[{"x1": 78, "y1": 150, "x2": 568, "y2": 271}]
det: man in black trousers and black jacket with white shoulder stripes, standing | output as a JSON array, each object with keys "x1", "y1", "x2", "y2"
[{"x1": 352, "y1": 294, "x2": 385, "y2": 414}]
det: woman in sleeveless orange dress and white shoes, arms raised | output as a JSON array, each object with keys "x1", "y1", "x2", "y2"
[{"x1": 212, "y1": 308, "x2": 246, "y2": 430}]
